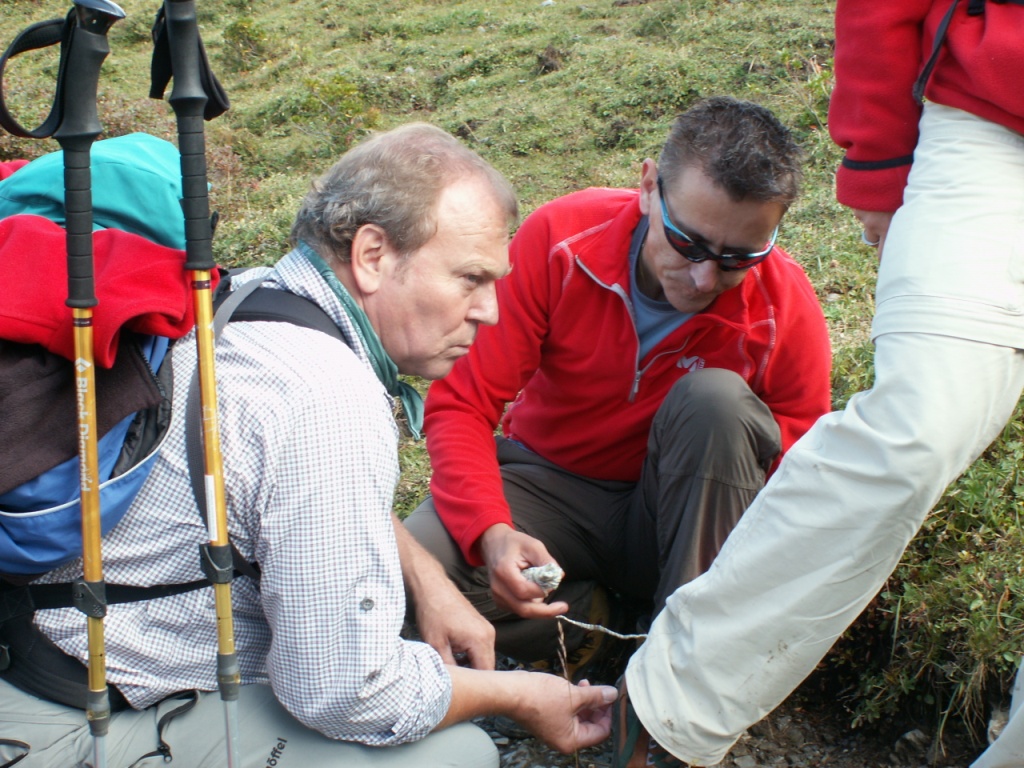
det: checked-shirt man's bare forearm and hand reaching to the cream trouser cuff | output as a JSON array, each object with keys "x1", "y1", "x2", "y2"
[{"x1": 437, "y1": 667, "x2": 618, "y2": 753}]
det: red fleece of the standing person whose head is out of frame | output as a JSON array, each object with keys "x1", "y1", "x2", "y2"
[{"x1": 828, "y1": 0, "x2": 1024, "y2": 211}]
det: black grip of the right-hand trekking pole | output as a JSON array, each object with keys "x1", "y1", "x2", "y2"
[{"x1": 164, "y1": 0, "x2": 217, "y2": 270}]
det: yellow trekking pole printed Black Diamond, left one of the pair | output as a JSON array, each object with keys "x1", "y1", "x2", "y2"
[{"x1": 53, "y1": 0, "x2": 125, "y2": 768}]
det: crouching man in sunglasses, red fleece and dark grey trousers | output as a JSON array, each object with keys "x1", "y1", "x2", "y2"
[{"x1": 407, "y1": 97, "x2": 830, "y2": 674}]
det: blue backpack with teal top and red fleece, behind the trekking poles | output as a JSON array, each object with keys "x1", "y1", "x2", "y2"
[{"x1": 0, "y1": 133, "x2": 193, "y2": 578}]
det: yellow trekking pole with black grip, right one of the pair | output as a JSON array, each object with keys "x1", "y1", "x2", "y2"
[{"x1": 151, "y1": 0, "x2": 242, "y2": 768}]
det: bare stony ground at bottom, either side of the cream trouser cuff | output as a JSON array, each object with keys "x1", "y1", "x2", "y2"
[{"x1": 479, "y1": 694, "x2": 980, "y2": 768}]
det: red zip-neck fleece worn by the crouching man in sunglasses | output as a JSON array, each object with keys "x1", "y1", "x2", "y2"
[{"x1": 425, "y1": 188, "x2": 831, "y2": 565}]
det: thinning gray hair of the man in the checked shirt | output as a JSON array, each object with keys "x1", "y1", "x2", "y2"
[{"x1": 291, "y1": 123, "x2": 519, "y2": 262}]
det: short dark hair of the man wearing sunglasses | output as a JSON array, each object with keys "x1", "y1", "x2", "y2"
[{"x1": 657, "y1": 96, "x2": 803, "y2": 208}]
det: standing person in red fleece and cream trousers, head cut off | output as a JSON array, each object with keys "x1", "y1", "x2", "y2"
[{"x1": 614, "y1": 0, "x2": 1024, "y2": 768}]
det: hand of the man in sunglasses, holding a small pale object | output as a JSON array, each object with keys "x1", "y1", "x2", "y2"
[{"x1": 480, "y1": 523, "x2": 569, "y2": 618}]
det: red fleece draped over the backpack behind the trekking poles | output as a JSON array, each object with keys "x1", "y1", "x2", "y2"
[{"x1": 0, "y1": 215, "x2": 219, "y2": 368}]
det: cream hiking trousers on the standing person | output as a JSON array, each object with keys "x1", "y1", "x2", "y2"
[{"x1": 627, "y1": 104, "x2": 1024, "y2": 768}]
